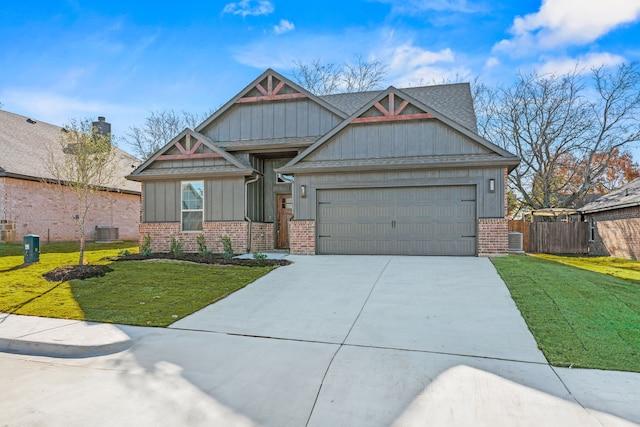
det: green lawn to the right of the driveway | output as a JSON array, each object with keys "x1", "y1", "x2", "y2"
[{"x1": 493, "y1": 255, "x2": 640, "y2": 372}]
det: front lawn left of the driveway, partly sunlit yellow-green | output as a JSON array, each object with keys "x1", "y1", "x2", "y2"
[{"x1": 0, "y1": 242, "x2": 272, "y2": 326}]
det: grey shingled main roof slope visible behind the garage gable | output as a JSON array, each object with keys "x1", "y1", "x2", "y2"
[{"x1": 320, "y1": 83, "x2": 478, "y2": 133}]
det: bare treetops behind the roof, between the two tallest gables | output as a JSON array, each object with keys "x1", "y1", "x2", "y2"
[{"x1": 292, "y1": 56, "x2": 387, "y2": 95}]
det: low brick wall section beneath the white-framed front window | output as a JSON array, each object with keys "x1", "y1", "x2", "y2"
[{"x1": 139, "y1": 221, "x2": 249, "y2": 254}]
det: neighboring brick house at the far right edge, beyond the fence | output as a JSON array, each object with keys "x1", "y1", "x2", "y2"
[{"x1": 578, "y1": 178, "x2": 640, "y2": 259}]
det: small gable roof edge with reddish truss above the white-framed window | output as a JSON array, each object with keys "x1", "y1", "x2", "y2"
[{"x1": 127, "y1": 128, "x2": 258, "y2": 181}]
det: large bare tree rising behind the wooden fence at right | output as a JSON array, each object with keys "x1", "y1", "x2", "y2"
[{"x1": 474, "y1": 64, "x2": 640, "y2": 209}]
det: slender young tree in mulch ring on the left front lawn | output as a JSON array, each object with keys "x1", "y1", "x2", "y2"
[{"x1": 45, "y1": 119, "x2": 117, "y2": 265}]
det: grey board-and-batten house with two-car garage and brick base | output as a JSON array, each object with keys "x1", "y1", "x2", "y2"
[{"x1": 128, "y1": 70, "x2": 519, "y2": 256}]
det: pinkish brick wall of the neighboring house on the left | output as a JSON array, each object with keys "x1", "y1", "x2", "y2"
[{"x1": 0, "y1": 178, "x2": 140, "y2": 244}]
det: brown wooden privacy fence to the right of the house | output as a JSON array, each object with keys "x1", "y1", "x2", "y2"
[{"x1": 509, "y1": 221, "x2": 589, "y2": 254}]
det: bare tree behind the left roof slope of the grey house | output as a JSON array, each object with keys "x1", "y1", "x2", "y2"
[{"x1": 125, "y1": 110, "x2": 213, "y2": 160}]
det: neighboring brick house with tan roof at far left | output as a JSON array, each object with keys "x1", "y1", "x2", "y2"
[{"x1": 0, "y1": 110, "x2": 141, "y2": 243}]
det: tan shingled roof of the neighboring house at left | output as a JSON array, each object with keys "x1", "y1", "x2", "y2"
[{"x1": 0, "y1": 110, "x2": 140, "y2": 194}]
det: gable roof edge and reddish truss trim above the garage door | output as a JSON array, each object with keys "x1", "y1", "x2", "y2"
[{"x1": 278, "y1": 86, "x2": 520, "y2": 173}]
